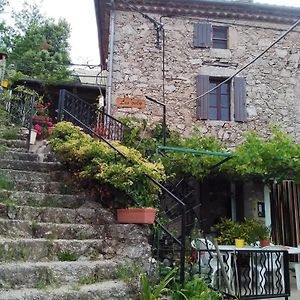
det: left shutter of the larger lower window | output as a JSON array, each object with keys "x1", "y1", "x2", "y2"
[{"x1": 196, "y1": 75, "x2": 209, "y2": 120}]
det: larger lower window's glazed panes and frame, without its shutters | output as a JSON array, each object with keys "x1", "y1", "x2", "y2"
[{"x1": 209, "y1": 79, "x2": 230, "y2": 121}]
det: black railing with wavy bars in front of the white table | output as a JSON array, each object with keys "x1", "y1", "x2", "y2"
[{"x1": 190, "y1": 246, "x2": 290, "y2": 299}]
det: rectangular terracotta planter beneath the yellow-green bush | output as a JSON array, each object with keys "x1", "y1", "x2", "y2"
[{"x1": 117, "y1": 207, "x2": 157, "y2": 224}]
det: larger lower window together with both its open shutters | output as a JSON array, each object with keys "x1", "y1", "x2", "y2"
[{"x1": 197, "y1": 75, "x2": 247, "y2": 122}]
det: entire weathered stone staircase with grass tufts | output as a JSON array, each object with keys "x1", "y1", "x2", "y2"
[{"x1": 0, "y1": 140, "x2": 150, "y2": 300}]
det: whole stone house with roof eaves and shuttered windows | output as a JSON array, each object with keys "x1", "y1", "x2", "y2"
[{"x1": 95, "y1": 0, "x2": 300, "y2": 243}]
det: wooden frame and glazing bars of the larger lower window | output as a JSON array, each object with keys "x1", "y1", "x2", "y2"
[{"x1": 208, "y1": 76, "x2": 232, "y2": 121}]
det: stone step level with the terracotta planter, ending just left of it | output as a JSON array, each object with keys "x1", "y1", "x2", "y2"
[{"x1": 0, "y1": 203, "x2": 114, "y2": 224}]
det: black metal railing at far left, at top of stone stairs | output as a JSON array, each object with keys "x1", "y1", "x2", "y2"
[{"x1": 1, "y1": 90, "x2": 35, "y2": 149}]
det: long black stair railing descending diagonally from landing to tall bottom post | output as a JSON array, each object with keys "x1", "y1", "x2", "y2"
[{"x1": 58, "y1": 90, "x2": 186, "y2": 286}]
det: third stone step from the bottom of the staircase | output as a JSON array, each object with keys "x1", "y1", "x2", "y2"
[{"x1": 0, "y1": 238, "x2": 109, "y2": 262}]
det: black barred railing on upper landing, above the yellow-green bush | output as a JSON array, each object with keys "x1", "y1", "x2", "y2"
[{"x1": 58, "y1": 90, "x2": 124, "y2": 140}]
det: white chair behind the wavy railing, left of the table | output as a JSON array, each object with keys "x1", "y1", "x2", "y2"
[{"x1": 191, "y1": 238, "x2": 232, "y2": 287}]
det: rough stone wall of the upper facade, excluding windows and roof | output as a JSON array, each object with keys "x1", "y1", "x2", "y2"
[{"x1": 112, "y1": 11, "x2": 300, "y2": 146}]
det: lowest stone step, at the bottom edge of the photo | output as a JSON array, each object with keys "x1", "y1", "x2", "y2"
[{"x1": 1, "y1": 280, "x2": 132, "y2": 300}]
